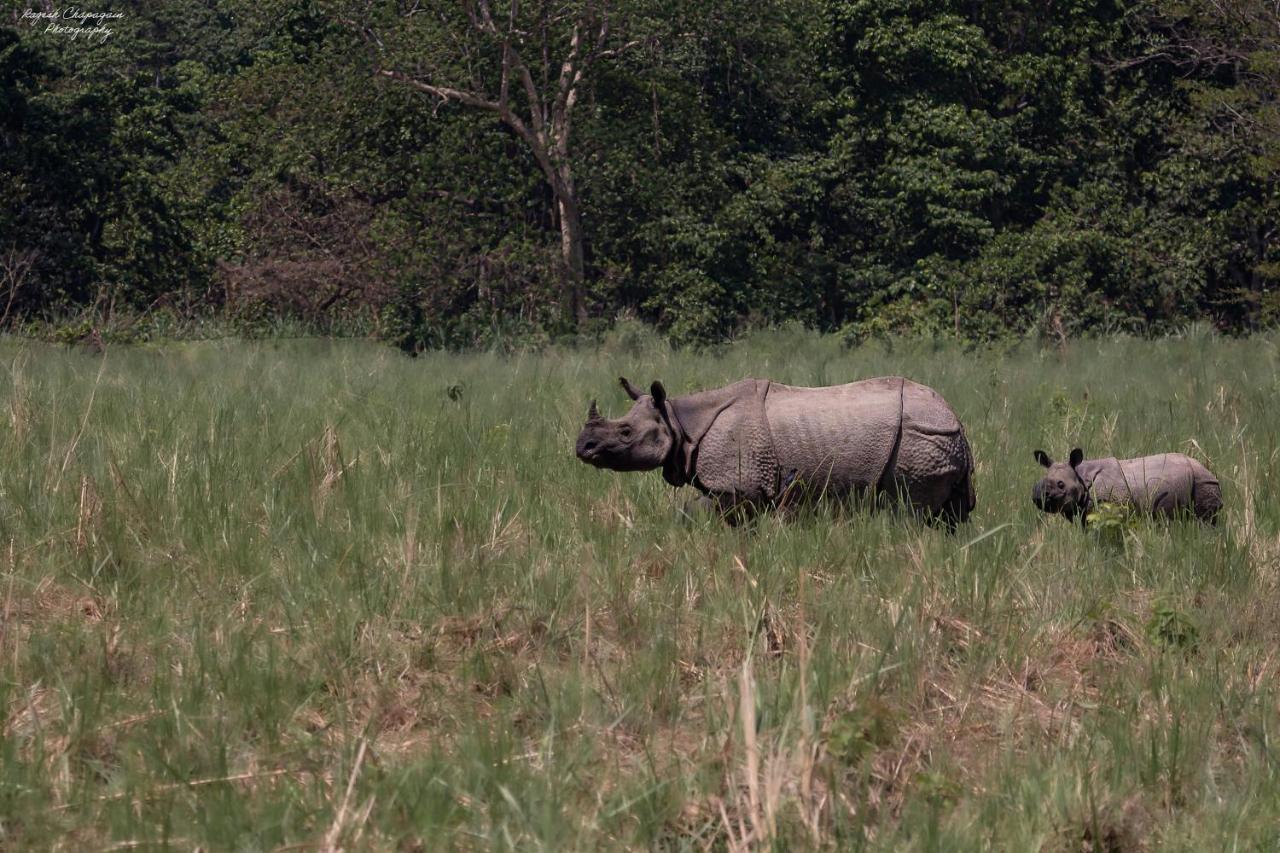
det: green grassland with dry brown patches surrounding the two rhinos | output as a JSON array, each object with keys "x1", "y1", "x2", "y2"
[{"x1": 0, "y1": 324, "x2": 1280, "y2": 850}]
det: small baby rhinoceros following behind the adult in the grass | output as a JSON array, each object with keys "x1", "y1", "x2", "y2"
[{"x1": 1032, "y1": 447, "x2": 1222, "y2": 525}]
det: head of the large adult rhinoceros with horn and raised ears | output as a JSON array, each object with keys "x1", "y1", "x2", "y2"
[{"x1": 576, "y1": 379, "x2": 675, "y2": 471}]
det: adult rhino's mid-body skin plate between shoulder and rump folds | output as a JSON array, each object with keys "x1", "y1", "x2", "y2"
[{"x1": 765, "y1": 377, "x2": 914, "y2": 491}]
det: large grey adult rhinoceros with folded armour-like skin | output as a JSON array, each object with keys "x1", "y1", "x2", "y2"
[{"x1": 577, "y1": 377, "x2": 974, "y2": 525}]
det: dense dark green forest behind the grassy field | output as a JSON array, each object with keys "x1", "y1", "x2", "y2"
[{"x1": 0, "y1": 0, "x2": 1280, "y2": 352}]
